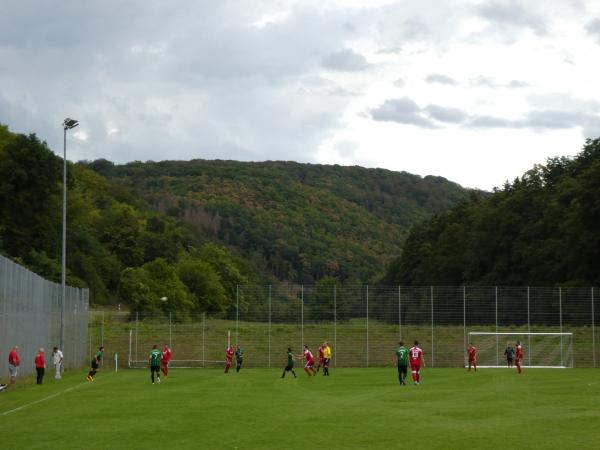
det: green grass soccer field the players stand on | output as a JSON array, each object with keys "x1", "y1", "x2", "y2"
[{"x1": 0, "y1": 368, "x2": 600, "y2": 450}]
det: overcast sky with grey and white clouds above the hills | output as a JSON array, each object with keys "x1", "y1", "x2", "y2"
[{"x1": 0, "y1": 0, "x2": 600, "y2": 189}]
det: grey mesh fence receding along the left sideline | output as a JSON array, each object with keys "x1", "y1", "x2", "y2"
[{"x1": 0, "y1": 256, "x2": 89, "y2": 378}]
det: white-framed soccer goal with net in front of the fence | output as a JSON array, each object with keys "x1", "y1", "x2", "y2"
[{"x1": 469, "y1": 331, "x2": 573, "y2": 369}]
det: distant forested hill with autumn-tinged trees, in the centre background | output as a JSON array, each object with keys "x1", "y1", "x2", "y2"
[{"x1": 85, "y1": 160, "x2": 469, "y2": 282}]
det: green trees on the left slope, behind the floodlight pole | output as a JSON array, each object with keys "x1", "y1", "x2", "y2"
[{"x1": 0, "y1": 126, "x2": 252, "y2": 313}]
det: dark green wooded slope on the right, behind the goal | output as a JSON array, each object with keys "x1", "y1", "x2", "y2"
[{"x1": 385, "y1": 139, "x2": 600, "y2": 286}]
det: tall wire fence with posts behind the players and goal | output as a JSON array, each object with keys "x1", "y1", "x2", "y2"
[{"x1": 90, "y1": 284, "x2": 598, "y2": 367}]
